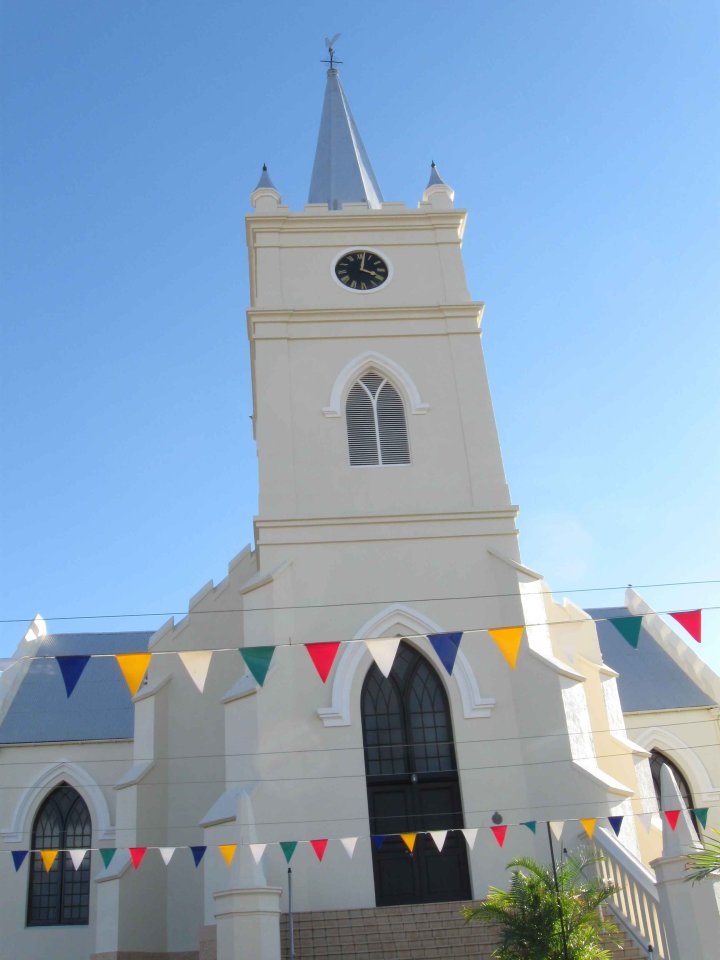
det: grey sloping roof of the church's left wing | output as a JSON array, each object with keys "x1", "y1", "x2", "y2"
[{"x1": 0, "y1": 631, "x2": 152, "y2": 744}]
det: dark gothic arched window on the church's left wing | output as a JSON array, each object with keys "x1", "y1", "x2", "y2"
[{"x1": 27, "y1": 783, "x2": 92, "y2": 927}]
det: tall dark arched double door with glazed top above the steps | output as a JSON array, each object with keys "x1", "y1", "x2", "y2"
[{"x1": 361, "y1": 641, "x2": 471, "y2": 906}]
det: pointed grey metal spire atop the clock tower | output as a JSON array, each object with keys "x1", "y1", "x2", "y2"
[{"x1": 308, "y1": 68, "x2": 382, "y2": 210}]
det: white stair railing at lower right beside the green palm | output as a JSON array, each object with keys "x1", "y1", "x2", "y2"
[{"x1": 593, "y1": 828, "x2": 670, "y2": 960}]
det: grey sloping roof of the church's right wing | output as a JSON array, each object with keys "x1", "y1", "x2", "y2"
[{"x1": 586, "y1": 607, "x2": 714, "y2": 712}]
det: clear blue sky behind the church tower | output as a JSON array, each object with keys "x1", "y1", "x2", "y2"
[{"x1": 0, "y1": 0, "x2": 720, "y2": 670}]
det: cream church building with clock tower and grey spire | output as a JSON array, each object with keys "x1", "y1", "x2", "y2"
[{"x1": 0, "y1": 60, "x2": 720, "y2": 960}]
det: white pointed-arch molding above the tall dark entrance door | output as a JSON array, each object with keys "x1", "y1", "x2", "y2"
[{"x1": 317, "y1": 603, "x2": 495, "y2": 727}]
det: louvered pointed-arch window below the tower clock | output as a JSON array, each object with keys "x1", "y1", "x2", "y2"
[{"x1": 345, "y1": 370, "x2": 410, "y2": 467}]
